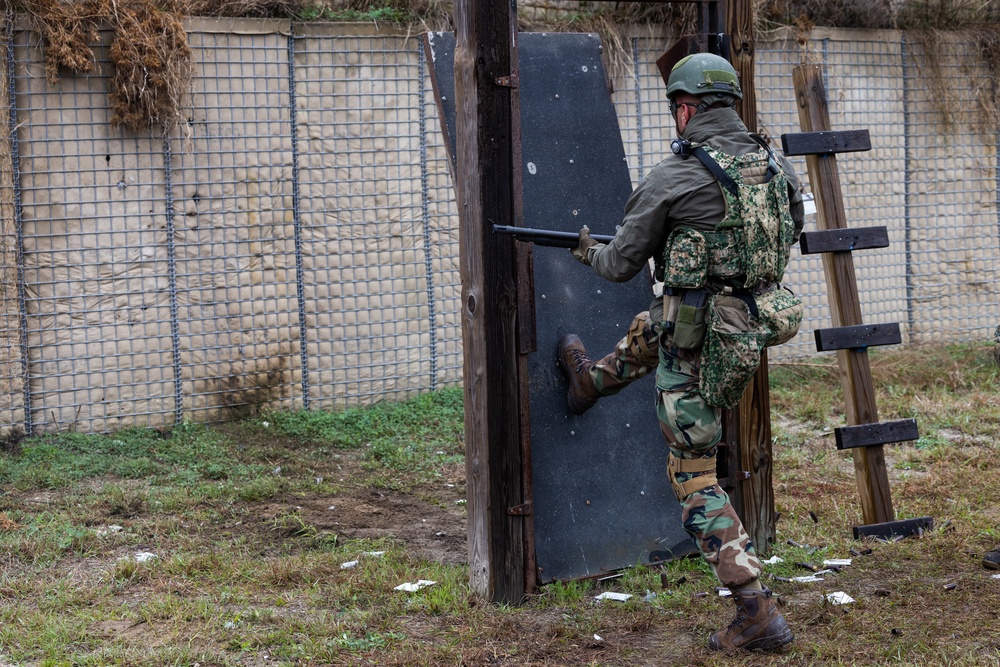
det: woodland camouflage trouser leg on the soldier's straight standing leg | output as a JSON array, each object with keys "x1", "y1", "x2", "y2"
[{"x1": 656, "y1": 336, "x2": 763, "y2": 590}]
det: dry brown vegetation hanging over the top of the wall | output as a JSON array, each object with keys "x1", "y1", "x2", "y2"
[{"x1": 6, "y1": 0, "x2": 1000, "y2": 131}]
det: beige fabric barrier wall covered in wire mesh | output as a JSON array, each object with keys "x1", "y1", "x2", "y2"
[{"x1": 0, "y1": 20, "x2": 1000, "y2": 433}]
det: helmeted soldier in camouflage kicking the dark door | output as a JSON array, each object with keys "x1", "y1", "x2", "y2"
[{"x1": 558, "y1": 54, "x2": 803, "y2": 650}]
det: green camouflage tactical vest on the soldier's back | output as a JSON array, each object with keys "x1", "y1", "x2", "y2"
[{"x1": 704, "y1": 146, "x2": 795, "y2": 288}]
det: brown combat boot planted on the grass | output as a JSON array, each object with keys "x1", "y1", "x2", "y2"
[{"x1": 708, "y1": 588, "x2": 795, "y2": 651}]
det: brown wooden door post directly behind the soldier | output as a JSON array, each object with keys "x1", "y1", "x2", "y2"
[{"x1": 726, "y1": 0, "x2": 775, "y2": 555}]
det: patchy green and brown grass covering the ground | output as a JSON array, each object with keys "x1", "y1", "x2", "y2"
[{"x1": 0, "y1": 366, "x2": 1000, "y2": 667}]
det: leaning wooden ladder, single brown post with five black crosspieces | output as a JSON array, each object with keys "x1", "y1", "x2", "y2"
[{"x1": 781, "y1": 65, "x2": 934, "y2": 539}]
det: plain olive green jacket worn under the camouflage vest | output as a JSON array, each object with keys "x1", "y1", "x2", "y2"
[{"x1": 588, "y1": 109, "x2": 804, "y2": 322}]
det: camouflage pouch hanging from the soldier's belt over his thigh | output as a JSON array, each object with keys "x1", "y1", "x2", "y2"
[{"x1": 700, "y1": 294, "x2": 771, "y2": 409}]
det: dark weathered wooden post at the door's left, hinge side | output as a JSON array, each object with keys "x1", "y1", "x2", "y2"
[{"x1": 454, "y1": 0, "x2": 525, "y2": 604}]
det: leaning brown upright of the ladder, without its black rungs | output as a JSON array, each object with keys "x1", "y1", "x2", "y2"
[{"x1": 792, "y1": 65, "x2": 895, "y2": 524}]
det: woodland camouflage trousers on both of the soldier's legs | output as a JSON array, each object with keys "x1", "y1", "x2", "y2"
[{"x1": 590, "y1": 312, "x2": 762, "y2": 590}]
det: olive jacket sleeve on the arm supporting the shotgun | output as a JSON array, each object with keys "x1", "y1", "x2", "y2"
[{"x1": 589, "y1": 172, "x2": 669, "y2": 282}]
